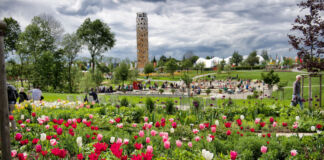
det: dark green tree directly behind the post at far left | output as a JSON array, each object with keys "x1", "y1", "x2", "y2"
[{"x1": 3, "y1": 17, "x2": 21, "y2": 57}]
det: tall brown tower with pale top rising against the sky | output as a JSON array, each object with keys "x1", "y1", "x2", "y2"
[{"x1": 136, "y1": 12, "x2": 149, "y2": 70}]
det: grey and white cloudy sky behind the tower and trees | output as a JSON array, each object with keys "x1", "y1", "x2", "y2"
[{"x1": 0, "y1": 0, "x2": 300, "y2": 60}]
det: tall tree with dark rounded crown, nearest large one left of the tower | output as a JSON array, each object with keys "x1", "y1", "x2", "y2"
[{"x1": 77, "y1": 18, "x2": 116, "y2": 73}]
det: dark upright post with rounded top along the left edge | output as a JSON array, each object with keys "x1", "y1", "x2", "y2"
[{"x1": 0, "y1": 21, "x2": 11, "y2": 160}]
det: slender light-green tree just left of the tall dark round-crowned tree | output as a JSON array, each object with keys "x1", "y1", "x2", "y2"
[{"x1": 62, "y1": 33, "x2": 82, "y2": 92}]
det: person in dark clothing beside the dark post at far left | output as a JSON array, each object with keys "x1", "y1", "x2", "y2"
[{"x1": 7, "y1": 83, "x2": 18, "y2": 131}]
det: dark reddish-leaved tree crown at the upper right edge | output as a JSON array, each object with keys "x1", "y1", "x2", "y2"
[{"x1": 288, "y1": 0, "x2": 324, "y2": 72}]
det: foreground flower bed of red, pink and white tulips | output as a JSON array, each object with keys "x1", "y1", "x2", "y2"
[{"x1": 9, "y1": 97, "x2": 324, "y2": 160}]
